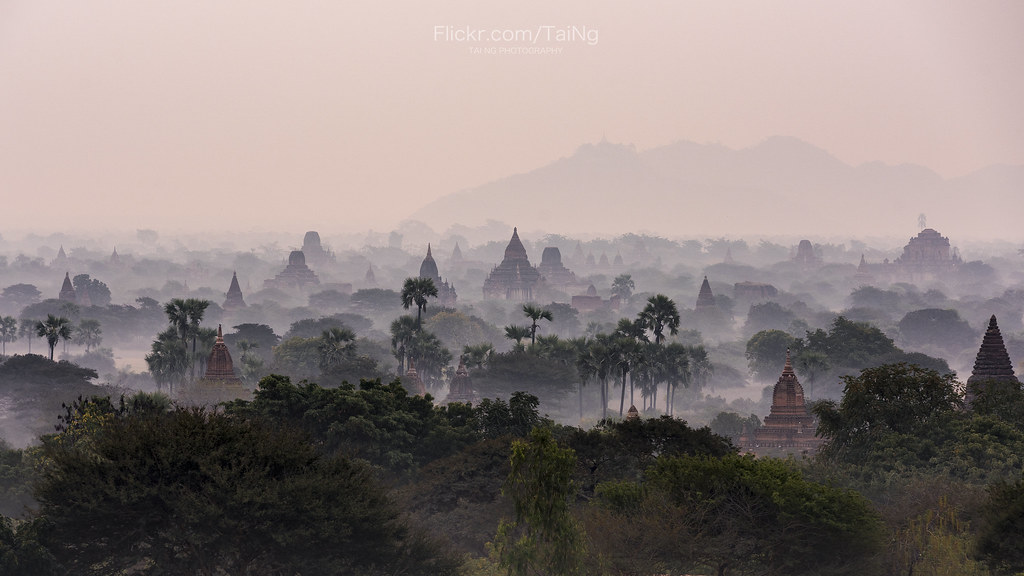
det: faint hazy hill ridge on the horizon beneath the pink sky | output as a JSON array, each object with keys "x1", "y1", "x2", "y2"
[{"x1": 411, "y1": 136, "x2": 1024, "y2": 238}]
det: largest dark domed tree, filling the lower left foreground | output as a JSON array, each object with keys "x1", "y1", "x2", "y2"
[{"x1": 38, "y1": 409, "x2": 456, "y2": 575}]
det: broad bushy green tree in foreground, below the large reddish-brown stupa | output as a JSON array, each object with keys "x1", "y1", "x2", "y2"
[{"x1": 646, "y1": 456, "x2": 884, "y2": 576}]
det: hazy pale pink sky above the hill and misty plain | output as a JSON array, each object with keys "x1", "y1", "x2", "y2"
[{"x1": 0, "y1": 0, "x2": 1024, "y2": 235}]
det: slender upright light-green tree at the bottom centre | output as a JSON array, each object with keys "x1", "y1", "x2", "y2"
[{"x1": 495, "y1": 428, "x2": 586, "y2": 576}]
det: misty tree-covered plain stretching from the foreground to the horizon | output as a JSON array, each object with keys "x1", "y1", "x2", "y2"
[{"x1": 0, "y1": 222, "x2": 1024, "y2": 575}]
